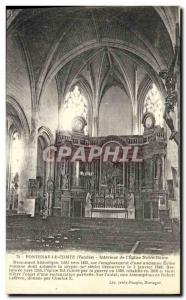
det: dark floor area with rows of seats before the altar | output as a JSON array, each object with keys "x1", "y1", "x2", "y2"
[{"x1": 7, "y1": 217, "x2": 179, "y2": 254}]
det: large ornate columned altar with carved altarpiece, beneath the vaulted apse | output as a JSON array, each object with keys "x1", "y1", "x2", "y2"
[{"x1": 52, "y1": 122, "x2": 166, "y2": 220}]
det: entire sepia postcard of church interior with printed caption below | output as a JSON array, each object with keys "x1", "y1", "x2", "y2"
[{"x1": 6, "y1": 3, "x2": 182, "y2": 294}]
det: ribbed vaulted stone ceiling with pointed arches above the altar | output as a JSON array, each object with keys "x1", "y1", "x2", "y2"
[{"x1": 7, "y1": 7, "x2": 178, "y2": 111}]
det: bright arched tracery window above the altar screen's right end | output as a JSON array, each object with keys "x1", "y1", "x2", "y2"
[{"x1": 143, "y1": 83, "x2": 164, "y2": 127}]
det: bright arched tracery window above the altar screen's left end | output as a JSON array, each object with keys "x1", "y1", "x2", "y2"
[{"x1": 62, "y1": 86, "x2": 88, "y2": 135}]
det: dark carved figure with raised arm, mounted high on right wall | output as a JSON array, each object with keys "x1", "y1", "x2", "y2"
[{"x1": 159, "y1": 41, "x2": 179, "y2": 144}]
